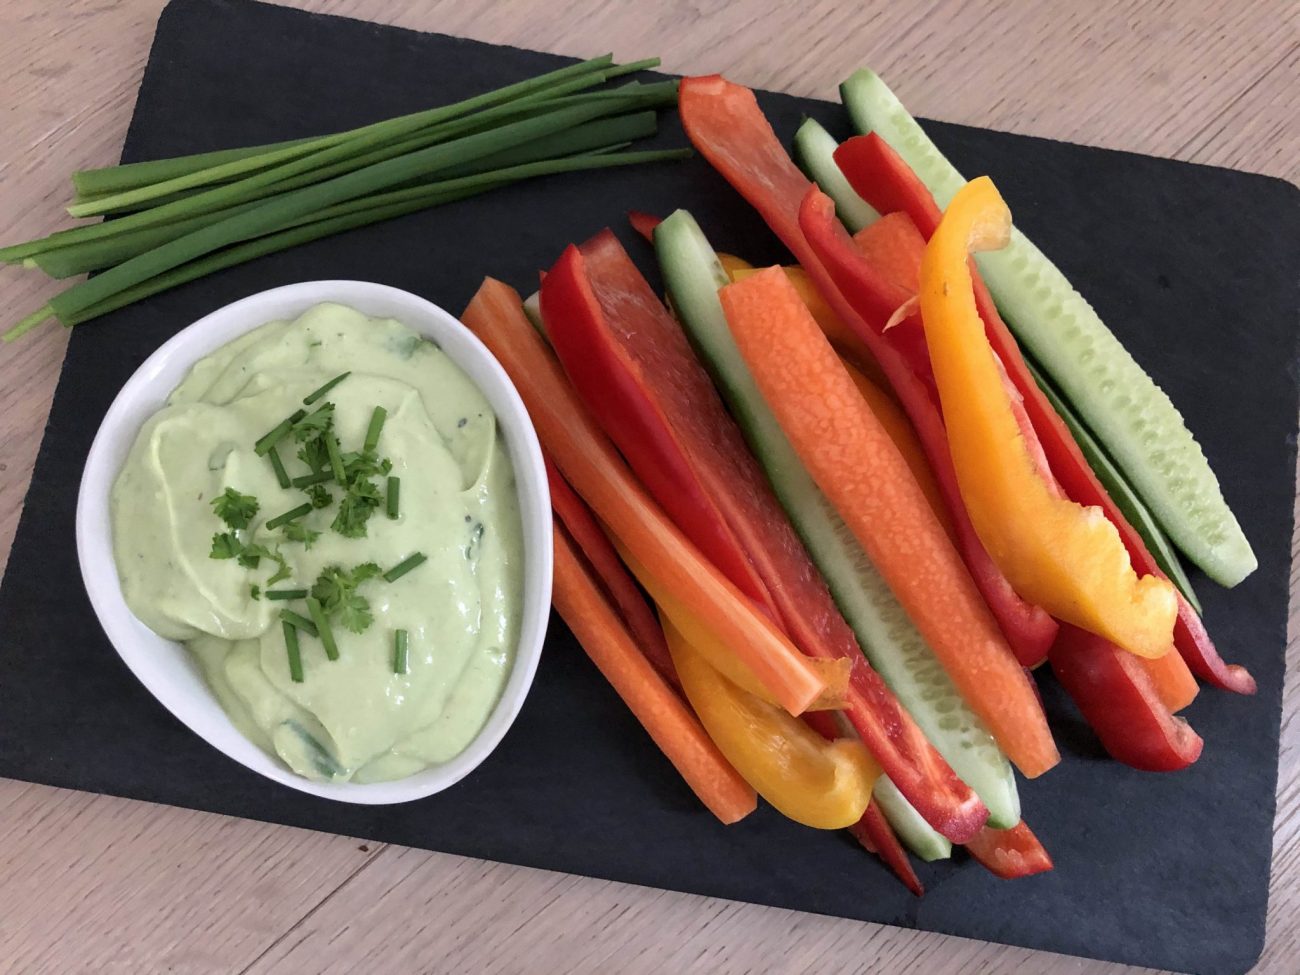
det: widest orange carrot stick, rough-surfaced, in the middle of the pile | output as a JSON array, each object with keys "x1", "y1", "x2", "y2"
[{"x1": 722, "y1": 268, "x2": 1060, "y2": 777}]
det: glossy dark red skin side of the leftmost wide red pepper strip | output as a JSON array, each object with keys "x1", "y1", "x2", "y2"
[{"x1": 542, "y1": 246, "x2": 777, "y2": 620}]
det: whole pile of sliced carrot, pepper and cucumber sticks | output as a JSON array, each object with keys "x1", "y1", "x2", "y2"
[{"x1": 464, "y1": 65, "x2": 1255, "y2": 893}]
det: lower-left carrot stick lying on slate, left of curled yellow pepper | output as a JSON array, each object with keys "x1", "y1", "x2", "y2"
[{"x1": 554, "y1": 525, "x2": 758, "y2": 823}]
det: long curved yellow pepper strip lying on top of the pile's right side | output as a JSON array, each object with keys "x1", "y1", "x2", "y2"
[{"x1": 920, "y1": 177, "x2": 1178, "y2": 657}]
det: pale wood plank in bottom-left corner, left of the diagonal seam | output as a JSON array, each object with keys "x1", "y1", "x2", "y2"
[{"x1": 0, "y1": 783, "x2": 382, "y2": 975}]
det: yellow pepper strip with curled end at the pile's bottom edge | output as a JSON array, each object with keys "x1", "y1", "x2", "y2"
[{"x1": 663, "y1": 615, "x2": 880, "y2": 829}]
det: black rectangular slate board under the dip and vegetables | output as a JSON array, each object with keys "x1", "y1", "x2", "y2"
[{"x1": 0, "y1": 0, "x2": 1300, "y2": 972}]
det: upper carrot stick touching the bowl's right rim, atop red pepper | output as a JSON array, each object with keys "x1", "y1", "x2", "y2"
[{"x1": 460, "y1": 278, "x2": 826, "y2": 714}]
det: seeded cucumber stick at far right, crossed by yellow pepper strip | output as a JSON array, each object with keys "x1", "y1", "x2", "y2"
[{"x1": 840, "y1": 70, "x2": 1257, "y2": 586}]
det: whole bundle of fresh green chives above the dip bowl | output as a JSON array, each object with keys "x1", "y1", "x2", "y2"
[{"x1": 0, "y1": 55, "x2": 689, "y2": 341}]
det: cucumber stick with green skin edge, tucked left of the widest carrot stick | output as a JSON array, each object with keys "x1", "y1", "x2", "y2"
[{"x1": 654, "y1": 211, "x2": 1021, "y2": 828}]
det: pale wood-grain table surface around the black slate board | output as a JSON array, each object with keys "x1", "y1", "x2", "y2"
[{"x1": 0, "y1": 0, "x2": 1300, "y2": 975}]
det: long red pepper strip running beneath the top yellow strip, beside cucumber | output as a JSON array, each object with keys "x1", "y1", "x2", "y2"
[{"x1": 835, "y1": 133, "x2": 1255, "y2": 694}]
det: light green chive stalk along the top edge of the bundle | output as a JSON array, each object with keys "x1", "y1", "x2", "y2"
[{"x1": 68, "y1": 55, "x2": 614, "y2": 210}]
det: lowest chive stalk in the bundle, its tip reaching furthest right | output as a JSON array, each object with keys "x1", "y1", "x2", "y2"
[{"x1": 3, "y1": 150, "x2": 690, "y2": 342}]
